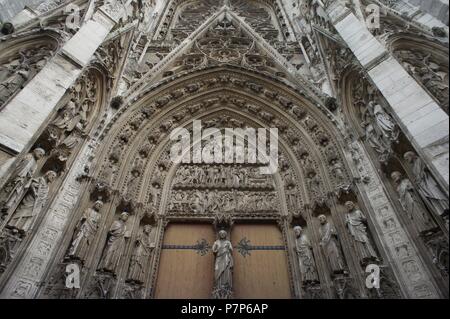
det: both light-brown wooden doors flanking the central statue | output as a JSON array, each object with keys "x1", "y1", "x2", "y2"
[{"x1": 155, "y1": 224, "x2": 291, "y2": 299}]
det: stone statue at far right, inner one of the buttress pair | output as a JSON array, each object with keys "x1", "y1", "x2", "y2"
[{"x1": 391, "y1": 172, "x2": 437, "y2": 233}]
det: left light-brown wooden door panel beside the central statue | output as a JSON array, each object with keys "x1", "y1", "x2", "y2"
[{"x1": 155, "y1": 224, "x2": 215, "y2": 299}]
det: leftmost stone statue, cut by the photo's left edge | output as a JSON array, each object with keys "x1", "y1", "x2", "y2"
[{"x1": 1, "y1": 148, "x2": 45, "y2": 214}]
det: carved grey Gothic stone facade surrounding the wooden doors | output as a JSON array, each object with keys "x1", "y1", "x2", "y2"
[{"x1": 0, "y1": 0, "x2": 449, "y2": 299}]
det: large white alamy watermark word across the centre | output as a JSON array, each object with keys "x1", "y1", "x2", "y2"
[{"x1": 170, "y1": 121, "x2": 278, "y2": 175}]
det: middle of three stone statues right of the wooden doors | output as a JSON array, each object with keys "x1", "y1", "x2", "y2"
[{"x1": 319, "y1": 215, "x2": 345, "y2": 274}]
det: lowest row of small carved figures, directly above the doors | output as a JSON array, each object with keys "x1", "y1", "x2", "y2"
[{"x1": 169, "y1": 190, "x2": 279, "y2": 214}]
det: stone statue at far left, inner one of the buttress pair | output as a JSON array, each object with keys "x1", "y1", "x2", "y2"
[{"x1": 7, "y1": 171, "x2": 57, "y2": 234}]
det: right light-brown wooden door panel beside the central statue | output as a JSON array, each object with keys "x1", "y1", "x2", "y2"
[{"x1": 232, "y1": 225, "x2": 291, "y2": 299}]
